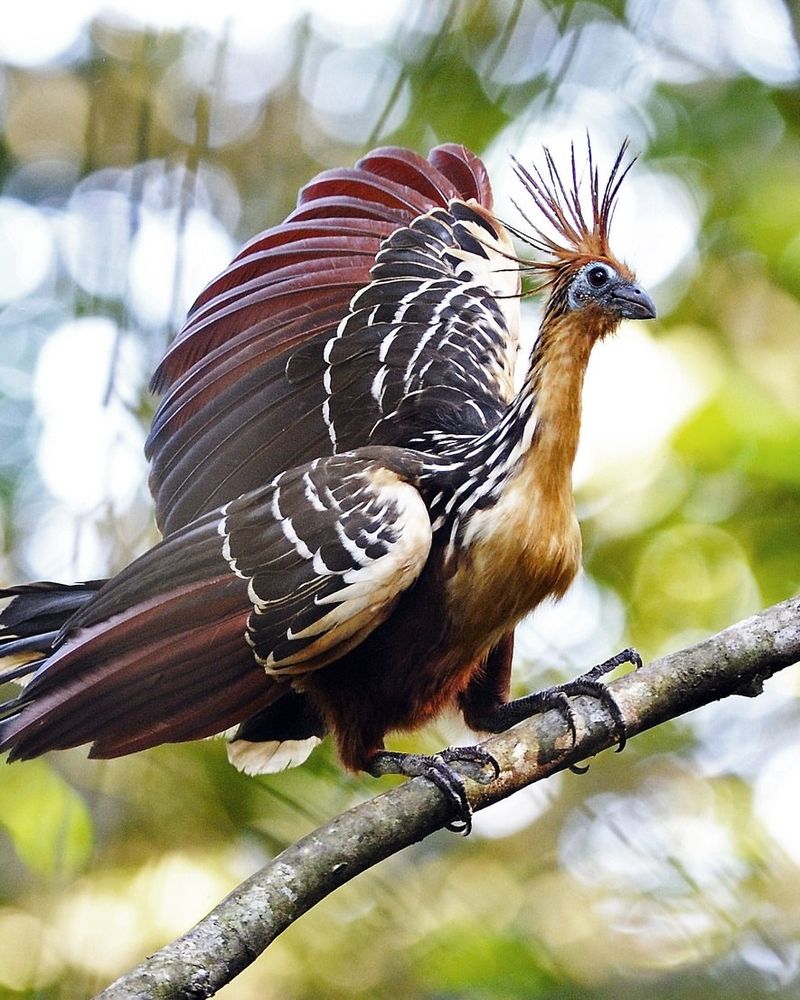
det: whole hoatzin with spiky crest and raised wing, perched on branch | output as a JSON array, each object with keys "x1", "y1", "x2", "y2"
[{"x1": 0, "y1": 139, "x2": 655, "y2": 830}]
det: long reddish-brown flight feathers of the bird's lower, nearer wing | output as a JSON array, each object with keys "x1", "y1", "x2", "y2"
[{"x1": 0, "y1": 579, "x2": 274, "y2": 761}]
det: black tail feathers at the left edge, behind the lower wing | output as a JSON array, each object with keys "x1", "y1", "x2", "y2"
[{"x1": 0, "y1": 580, "x2": 106, "y2": 682}]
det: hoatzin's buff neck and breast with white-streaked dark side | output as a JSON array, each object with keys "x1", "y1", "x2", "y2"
[{"x1": 432, "y1": 318, "x2": 594, "y2": 652}]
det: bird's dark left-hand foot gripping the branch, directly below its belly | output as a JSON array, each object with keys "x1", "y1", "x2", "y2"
[{"x1": 367, "y1": 746, "x2": 500, "y2": 837}]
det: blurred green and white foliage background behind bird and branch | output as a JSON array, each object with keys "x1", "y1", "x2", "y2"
[{"x1": 0, "y1": 0, "x2": 800, "y2": 1000}]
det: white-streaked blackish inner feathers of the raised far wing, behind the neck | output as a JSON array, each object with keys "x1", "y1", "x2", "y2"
[{"x1": 316, "y1": 202, "x2": 519, "y2": 451}]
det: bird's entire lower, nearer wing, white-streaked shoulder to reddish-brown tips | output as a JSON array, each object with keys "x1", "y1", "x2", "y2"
[{"x1": 0, "y1": 449, "x2": 431, "y2": 759}]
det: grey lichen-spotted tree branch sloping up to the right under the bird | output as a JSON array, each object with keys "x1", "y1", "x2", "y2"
[{"x1": 96, "y1": 597, "x2": 800, "y2": 1000}]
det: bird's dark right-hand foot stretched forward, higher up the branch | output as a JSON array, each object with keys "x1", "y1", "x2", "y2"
[{"x1": 462, "y1": 649, "x2": 642, "y2": 752}]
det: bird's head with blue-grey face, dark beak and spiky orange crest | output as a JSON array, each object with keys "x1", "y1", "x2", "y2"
[{"x1": 512, "y1": 140, "x2": 656, "y2": 336}]
